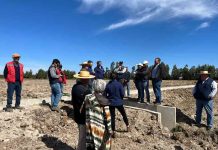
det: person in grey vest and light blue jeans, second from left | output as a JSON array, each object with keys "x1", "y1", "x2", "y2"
[{"x1": 48, "y1": 59, "x2": 62, "y2": 112}]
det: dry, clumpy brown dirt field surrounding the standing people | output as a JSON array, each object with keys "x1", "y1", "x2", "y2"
[{"x1": 0, "y1": 80, "x2": 218, "y2": 150}]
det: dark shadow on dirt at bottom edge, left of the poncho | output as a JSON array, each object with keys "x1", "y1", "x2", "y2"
[{"x1": 41, "y1": 135, "x2": 75, "y2": 150}]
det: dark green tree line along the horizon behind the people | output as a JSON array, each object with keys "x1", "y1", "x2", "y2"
[{"x1": 0, "y1": 62, "x2": 218, "y2": 80}]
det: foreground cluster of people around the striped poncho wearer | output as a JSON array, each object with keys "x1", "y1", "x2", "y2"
[{"x1": 71, "y1": 61, "x2": 130, "y2": 150}]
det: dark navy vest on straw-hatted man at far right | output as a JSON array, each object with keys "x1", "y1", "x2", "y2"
[{"x1": 194, "y1": 78, "x2": 213, "y2": 101}]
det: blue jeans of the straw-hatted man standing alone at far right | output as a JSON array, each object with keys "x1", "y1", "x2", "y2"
[{"x1": 196, "y1": 100, "x2": 213, "y2": 127}]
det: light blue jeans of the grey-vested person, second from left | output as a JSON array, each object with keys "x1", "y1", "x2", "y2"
[{"x1": 50, "y1": 83, "x2": 61, "y2": 107}]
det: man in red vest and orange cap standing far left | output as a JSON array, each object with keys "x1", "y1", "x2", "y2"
[{"x1": 4, "y1": 54, "x2": 24, "y2": 112}]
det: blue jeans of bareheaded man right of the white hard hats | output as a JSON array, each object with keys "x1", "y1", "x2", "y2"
[{"x1": 152, "y1": 79, "x2": 162, "y2": 103}]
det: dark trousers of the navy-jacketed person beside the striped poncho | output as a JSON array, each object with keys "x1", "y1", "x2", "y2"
[{"x1": 110, "y1": 105, "x2": 129, "y2": 131}]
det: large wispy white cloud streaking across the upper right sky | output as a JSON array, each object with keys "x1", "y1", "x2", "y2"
[{"x1": 80, "y1": 0, "x2": 218, "y2": 30}]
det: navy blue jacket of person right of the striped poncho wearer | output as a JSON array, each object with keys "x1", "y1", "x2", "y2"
[{"x1": 105, "y1": 80, "x2": 124, "y2": 106}]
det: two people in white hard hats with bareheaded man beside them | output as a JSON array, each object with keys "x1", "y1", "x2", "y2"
[{"x1": 134, "y1": 58, "x2": 166, "y2": 104}]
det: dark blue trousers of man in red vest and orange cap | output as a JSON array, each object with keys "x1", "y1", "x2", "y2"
[{"x1": 6, "y1": 81, "x2": 22, "y2": 107}]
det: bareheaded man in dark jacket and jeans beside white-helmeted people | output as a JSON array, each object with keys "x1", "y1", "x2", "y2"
[{"x1": 151, "y1": 58, "x2": 166, "y2": 105}]
